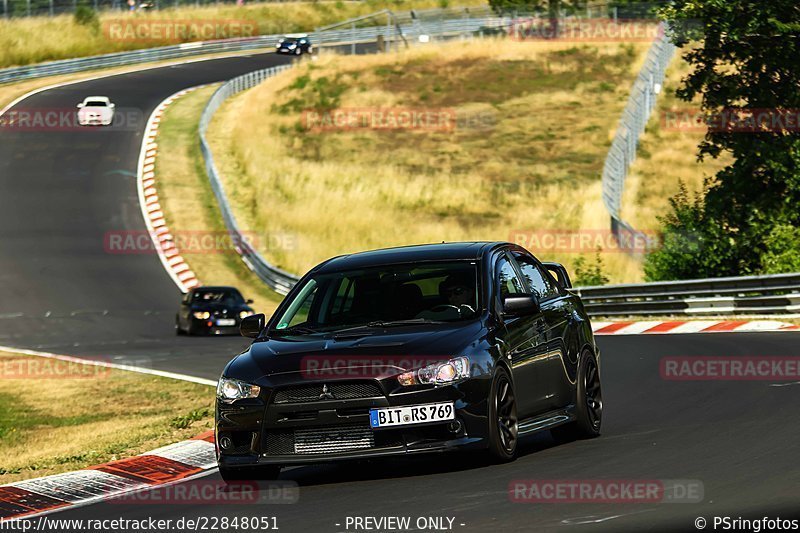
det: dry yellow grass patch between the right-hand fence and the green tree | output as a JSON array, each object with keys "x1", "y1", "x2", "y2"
[{"x1": 621, "y1": 56, "x2": 731, "y2": 231}]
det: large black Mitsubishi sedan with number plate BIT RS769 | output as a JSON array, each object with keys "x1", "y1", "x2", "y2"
[{"x1": 216, "y1": 242, "x2": 603, "y2": 480}]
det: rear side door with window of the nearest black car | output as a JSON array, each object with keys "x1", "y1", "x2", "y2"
[{"x1": 512, "y1": 251, "x2": 573, "y2": 411}]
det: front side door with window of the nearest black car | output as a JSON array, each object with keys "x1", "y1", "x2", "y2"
[{"x1": 495, "y1": 254, "x2": 542, "y2": 419}]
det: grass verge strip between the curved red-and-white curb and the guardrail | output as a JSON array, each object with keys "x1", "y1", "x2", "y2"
[{"x1": 156, "y1": 86, "x2": 281, "y2": 315}]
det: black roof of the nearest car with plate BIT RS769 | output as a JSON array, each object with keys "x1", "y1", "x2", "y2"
[{"x1": 314, "y1": 241, "x2": 508, "y2": 273}]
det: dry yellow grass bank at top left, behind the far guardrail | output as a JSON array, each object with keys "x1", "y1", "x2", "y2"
[{"x1": 0, "y1": 0, "x2": 486, "y2": 68}]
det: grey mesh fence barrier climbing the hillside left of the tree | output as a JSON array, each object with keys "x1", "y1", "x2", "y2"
[{"x1": 603, "y1": 24, "x2": 675, "y2": 254}]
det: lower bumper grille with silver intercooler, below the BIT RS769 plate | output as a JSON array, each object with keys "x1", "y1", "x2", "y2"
[{"x1": 264, "y1": 424, "x2": 403, "y2": 455}]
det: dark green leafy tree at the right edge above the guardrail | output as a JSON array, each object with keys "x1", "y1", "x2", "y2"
[{"x1": 650, "y1": 0, "x2": 800, "y2": 279}]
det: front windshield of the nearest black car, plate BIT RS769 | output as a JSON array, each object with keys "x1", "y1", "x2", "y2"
[{"x1": 273, "y1": 261, "x2": 479, "y2": 333}]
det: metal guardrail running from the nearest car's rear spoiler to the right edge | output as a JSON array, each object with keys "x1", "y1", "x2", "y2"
[{"x1": 575, "y1": 273, "x2": 800, "y2": 316}]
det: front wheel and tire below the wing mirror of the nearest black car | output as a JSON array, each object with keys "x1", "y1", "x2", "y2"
[{"x1": 489, "y1": 367, "x2": 519, "y2": 463}]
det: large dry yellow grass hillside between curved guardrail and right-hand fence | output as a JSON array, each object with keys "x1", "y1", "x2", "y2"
[{"x1": 210, "y1": 40, "x2": 648, "y2": 282}]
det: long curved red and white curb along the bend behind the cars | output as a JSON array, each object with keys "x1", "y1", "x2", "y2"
[{"x1": 137, "y1": 85, "x2": 205, "y2": 292}]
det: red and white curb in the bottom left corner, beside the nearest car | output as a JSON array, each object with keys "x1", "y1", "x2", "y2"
[{"x1": 0, "y1": 431, "x2": 217, "y2": 521}]
